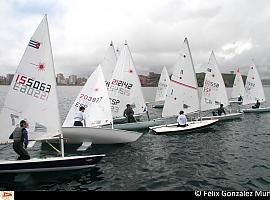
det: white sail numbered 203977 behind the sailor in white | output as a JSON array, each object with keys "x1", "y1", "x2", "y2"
[{"x1": 63, "y1": 65, "x2": 112, "y2": 127}]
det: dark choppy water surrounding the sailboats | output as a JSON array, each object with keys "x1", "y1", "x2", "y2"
[{"x1": 0, "y1": 86, "x2": 270, "y2": 191}]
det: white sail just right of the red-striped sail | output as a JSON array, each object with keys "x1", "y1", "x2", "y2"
[{"x1": 201, "y1": 51, "x2": 229, "y2": 111}]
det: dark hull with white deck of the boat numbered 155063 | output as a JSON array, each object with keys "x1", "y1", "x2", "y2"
[{"x1": 0, "y1": 154, "x2": 105, "y2": 173}]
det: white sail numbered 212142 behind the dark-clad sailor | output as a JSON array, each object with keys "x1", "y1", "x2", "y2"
[{"x1": 108, "y1": 43, "x2": 145, "y2": 117}]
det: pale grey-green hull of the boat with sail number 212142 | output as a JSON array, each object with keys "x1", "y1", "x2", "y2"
[{"x1": 105, "y1": 119, "x2": 165, "y2": 131}]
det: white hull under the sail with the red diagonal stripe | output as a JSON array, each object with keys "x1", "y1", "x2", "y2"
[{"x1": 150, "y1": 119, "x2": 218, "y2": 134}]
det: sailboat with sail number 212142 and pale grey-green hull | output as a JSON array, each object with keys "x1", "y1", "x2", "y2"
[{"x1": 104, "y1": 42, "x2": 164, "y2": 130}]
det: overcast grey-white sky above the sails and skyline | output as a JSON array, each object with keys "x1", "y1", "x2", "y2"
[{"x1": 0, "y1": 0, "x2": 270, "y2": 78}]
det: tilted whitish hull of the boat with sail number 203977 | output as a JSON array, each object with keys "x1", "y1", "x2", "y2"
[{"x1": 62, "y1": 127, "x2": 142, "y2": 144}]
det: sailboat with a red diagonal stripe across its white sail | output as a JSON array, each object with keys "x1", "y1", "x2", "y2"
[{"x1": 150, "y1": 38, "x2": 218, "y2": 134}]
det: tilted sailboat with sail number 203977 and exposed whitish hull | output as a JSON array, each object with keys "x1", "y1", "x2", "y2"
[{"x1": 62, "y1": 65, "x2": 142, "y2": 145}]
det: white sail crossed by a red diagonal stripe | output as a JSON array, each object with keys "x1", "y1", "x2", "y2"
[{"x1": 162, "y1": 38, "x2": 199, "y2": 117}]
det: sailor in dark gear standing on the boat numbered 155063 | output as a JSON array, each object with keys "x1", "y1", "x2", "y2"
[{"x1": 9, "y1": 120, "x2": 30, "y2": 160}]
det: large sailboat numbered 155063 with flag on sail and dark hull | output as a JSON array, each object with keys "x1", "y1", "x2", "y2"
[{"x1": 0, "y1": 15, "x2": 105, "y2": 173}]
